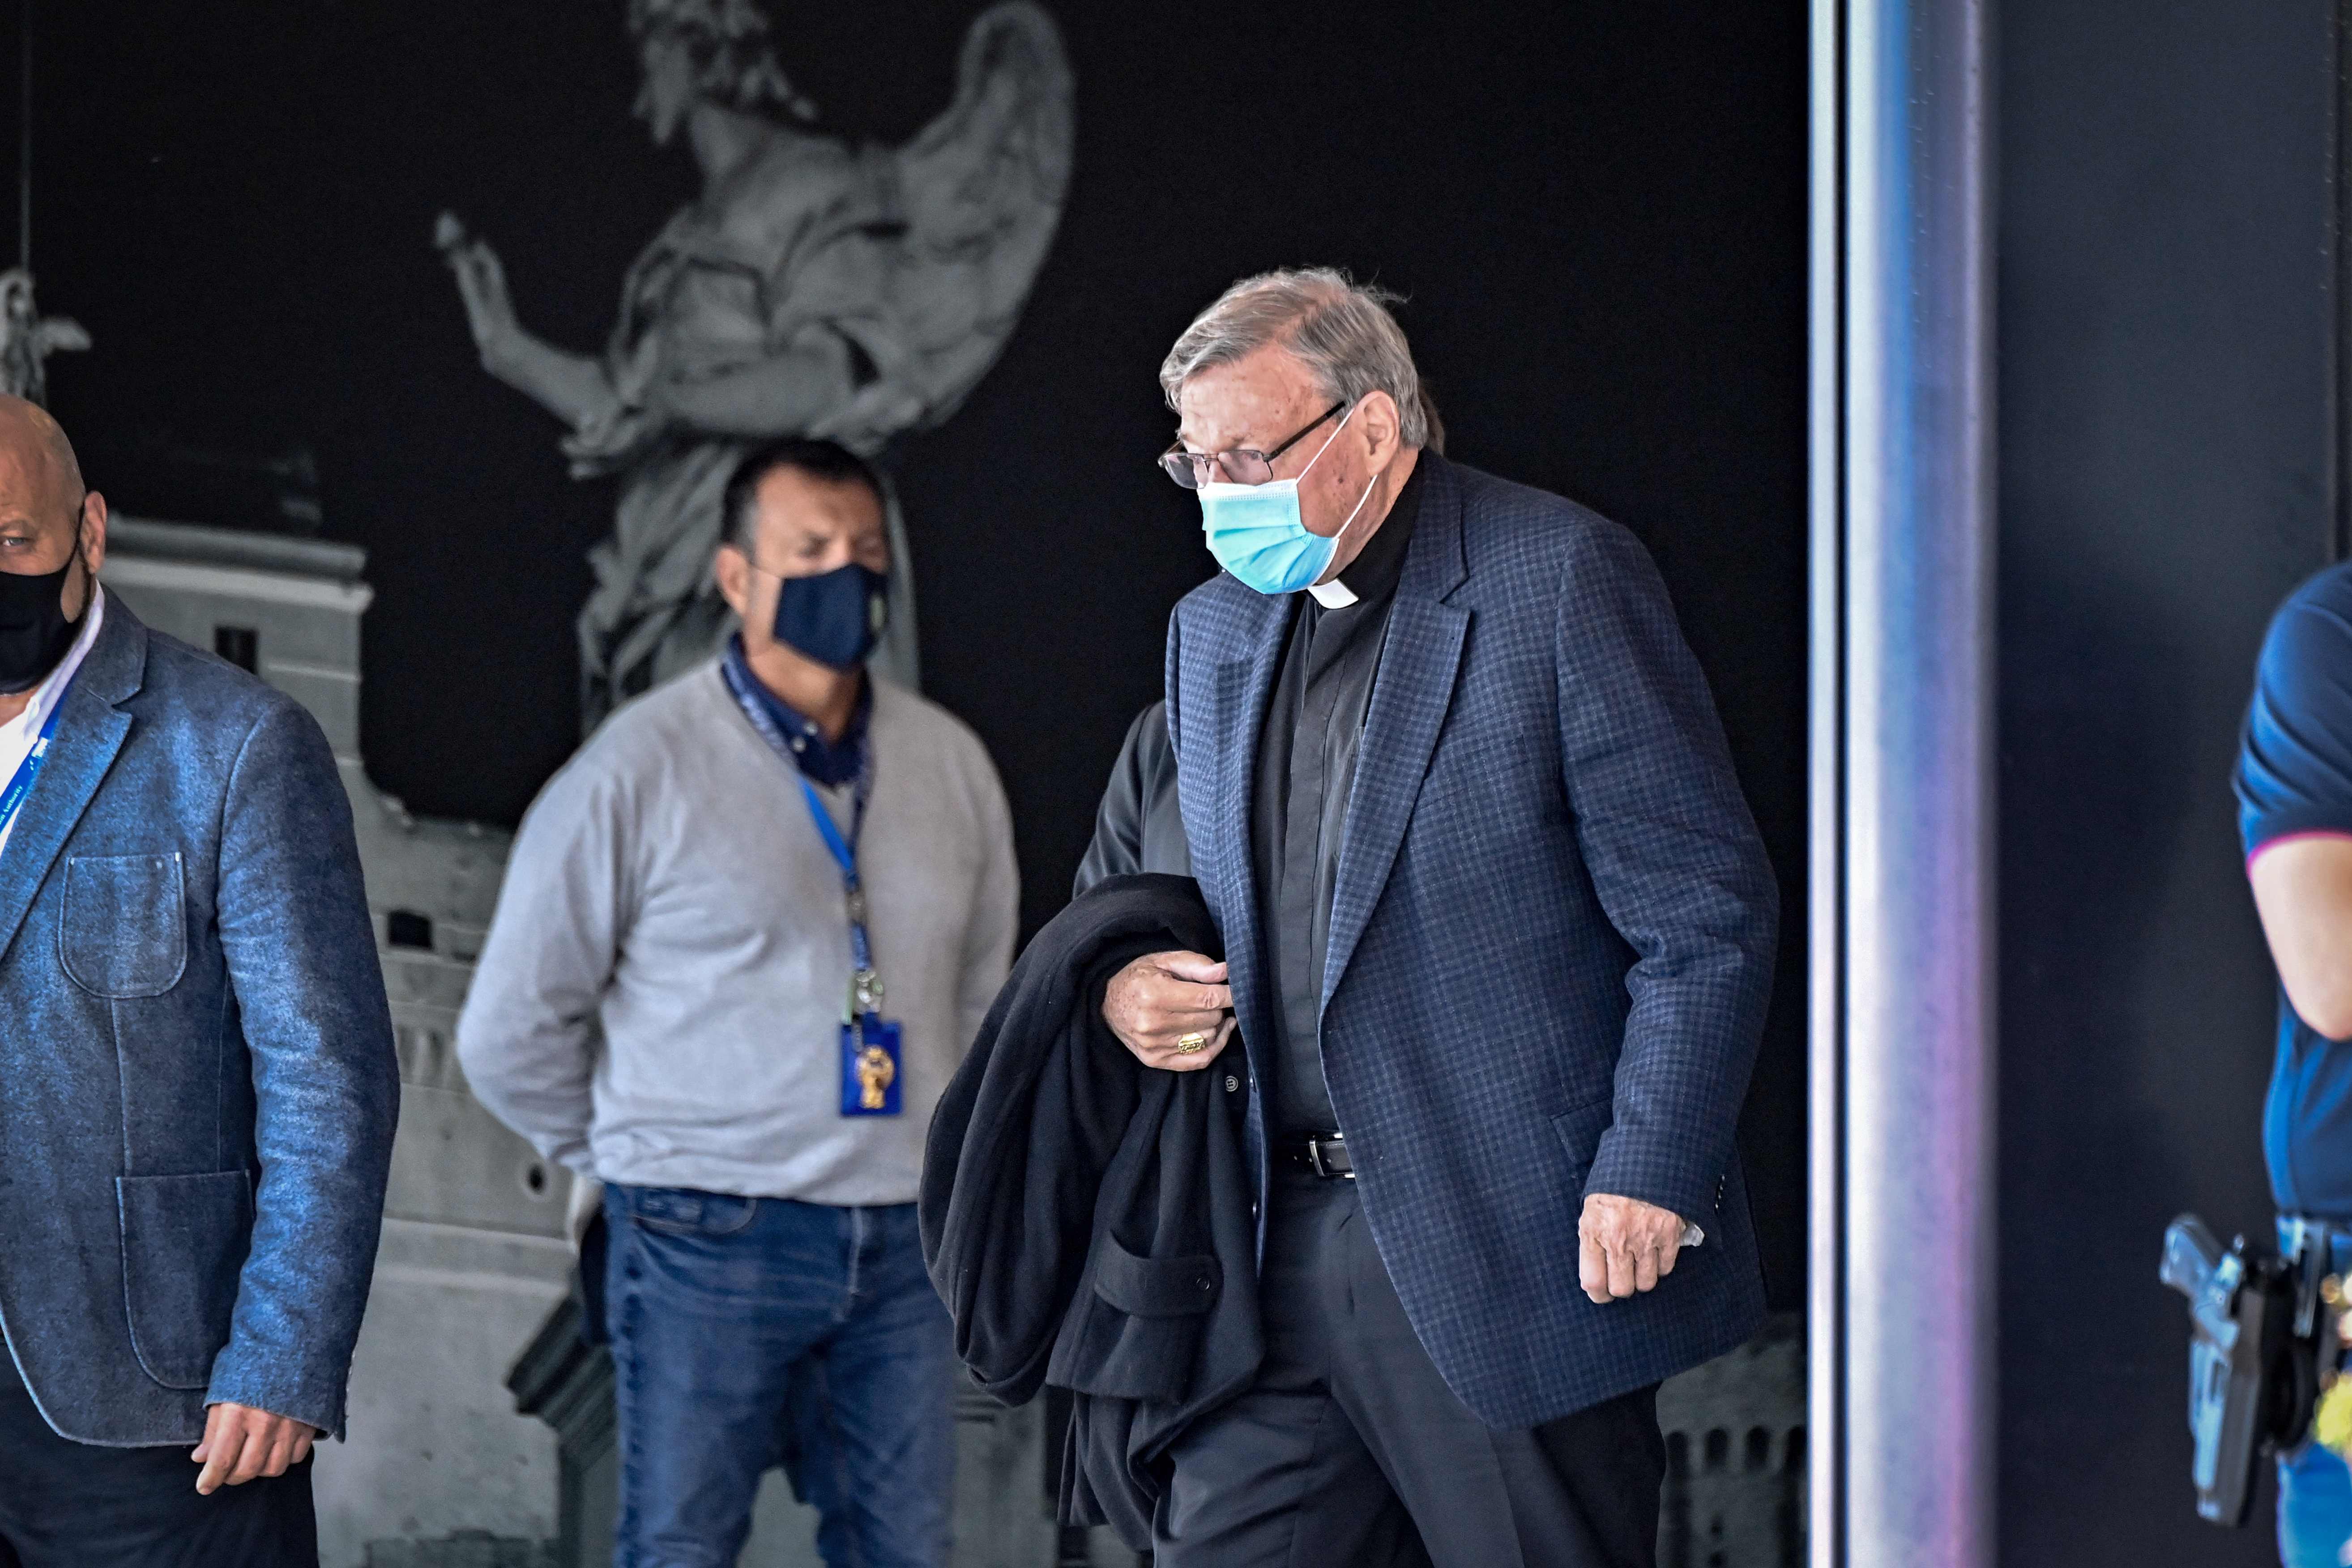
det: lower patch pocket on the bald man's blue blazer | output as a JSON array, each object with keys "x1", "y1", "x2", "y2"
[{"x1": 115, "y1": 1171, "x2": 254, "y2": 1389}]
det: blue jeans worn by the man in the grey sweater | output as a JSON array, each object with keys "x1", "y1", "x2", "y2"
[{"x1": 605, "y1": 1187, "x2": 955, "y2": 1568}]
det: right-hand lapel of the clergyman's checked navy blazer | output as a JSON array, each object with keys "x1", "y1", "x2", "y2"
[{"x1": 1322, "y1": 452, "x2": 1470, "y2": 1006}]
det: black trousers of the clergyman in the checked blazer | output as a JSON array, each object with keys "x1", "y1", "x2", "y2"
[{"x1": 1153, "y1": 1173, "x2": 1665, "y2": 1568}]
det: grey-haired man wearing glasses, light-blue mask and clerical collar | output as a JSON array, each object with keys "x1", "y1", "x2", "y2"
[{"x1": 1103, "y1": 270, "x2": 1778, "y2": 1568}]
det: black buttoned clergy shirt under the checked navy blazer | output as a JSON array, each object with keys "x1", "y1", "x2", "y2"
[{"x1": 1249, "y1": 463, "x2": 1421, "y2": 1133}]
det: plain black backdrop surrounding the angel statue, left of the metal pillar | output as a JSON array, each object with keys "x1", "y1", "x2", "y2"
[{"x1": 18, "y1": 0, "x2": 1804, "y2": 1307}]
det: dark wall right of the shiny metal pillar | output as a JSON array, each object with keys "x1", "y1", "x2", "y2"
[{"x1": 1999, "y1": 0, "x2": 2338, "y2": 1568}]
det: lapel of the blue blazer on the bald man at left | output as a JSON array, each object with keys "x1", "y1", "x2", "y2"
[{"x1": 0, "y1": 595, "x2": 146, "y2": 959}]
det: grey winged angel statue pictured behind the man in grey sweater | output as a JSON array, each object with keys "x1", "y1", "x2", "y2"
[{"x1": 435, "y1": 0, "x2": 1072, "y2": 729}]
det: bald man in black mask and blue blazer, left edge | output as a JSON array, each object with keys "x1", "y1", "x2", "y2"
[{"x1": 0, "y1": 397, "x2": 400, "y2": 1568}]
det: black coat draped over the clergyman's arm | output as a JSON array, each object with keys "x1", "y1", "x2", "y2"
[{"x1": 920, "y1": 874, "x2": 1261, "y2": 1544}]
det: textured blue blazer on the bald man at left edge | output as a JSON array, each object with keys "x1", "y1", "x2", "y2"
[{"x1": 0, "y1": 600, "x2": 400, "y2": 1446}]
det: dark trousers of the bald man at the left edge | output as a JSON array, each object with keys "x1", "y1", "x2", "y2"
[{"x1": 0, "y1": 1347, "x2": 317, "y2": 1568}]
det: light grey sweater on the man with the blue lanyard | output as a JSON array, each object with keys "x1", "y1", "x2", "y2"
[{"x1": 459, "y1": 663, "x2": 1018, "y2": 1204}]
